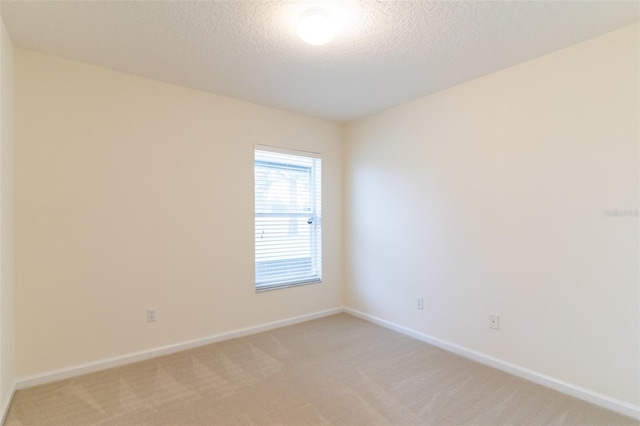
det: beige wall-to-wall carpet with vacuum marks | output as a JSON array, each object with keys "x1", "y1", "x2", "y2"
[{"x1": 6, "y1": 314, "x2": 638, "y2": 426}]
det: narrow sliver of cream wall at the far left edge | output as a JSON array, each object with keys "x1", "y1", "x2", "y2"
[{"x1": 0, "y1": 18, "x2": 14, "y2": 412}]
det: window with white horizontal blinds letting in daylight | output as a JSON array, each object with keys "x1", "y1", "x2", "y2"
[{"x1": 254, "y1": 147, "x2": 322, "y2": 290}]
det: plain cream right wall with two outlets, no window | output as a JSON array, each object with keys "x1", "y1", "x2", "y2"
[{"x1": 345, "y1": 25, "x2": 640, "y2": 406}]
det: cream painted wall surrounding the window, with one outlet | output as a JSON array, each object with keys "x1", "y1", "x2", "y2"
[{"x1": 15, "y1": 49, "x2": 343, "y2": 377}]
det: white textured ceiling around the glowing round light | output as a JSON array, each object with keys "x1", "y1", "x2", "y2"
[{"x1": 1, "y1": 0, "x2": 640, "y2": 122}]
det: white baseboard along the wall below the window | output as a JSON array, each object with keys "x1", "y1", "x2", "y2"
[{"x1": 16, "y1": 308, "x2": 343, "y2": 392}]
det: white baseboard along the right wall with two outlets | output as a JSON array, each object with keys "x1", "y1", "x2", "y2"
[{"x1": 344, "y1": 308, "x2": 640, "y2": 420}]
